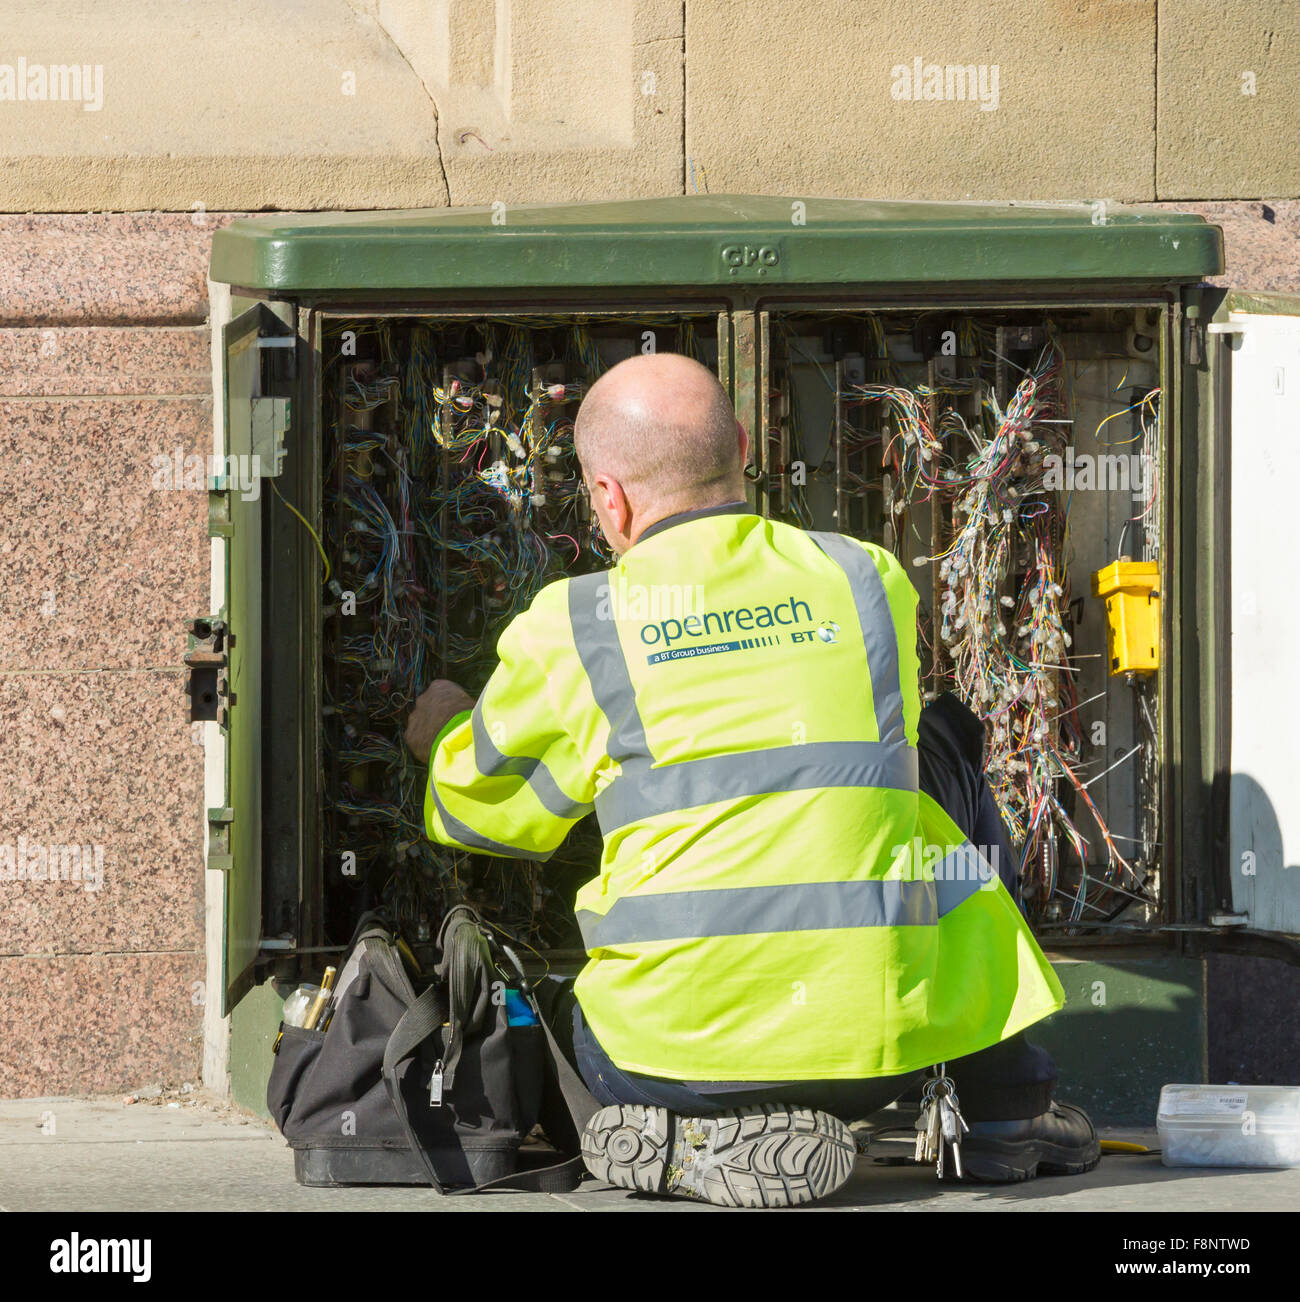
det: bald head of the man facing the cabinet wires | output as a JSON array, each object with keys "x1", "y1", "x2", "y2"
[{"x1": 573, "y1": 353, "x2": 745, "y2": 542}]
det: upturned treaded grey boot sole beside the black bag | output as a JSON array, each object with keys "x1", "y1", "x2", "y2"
[{"x1": 582, "y1": 1104, "x2": 857, "y2": 1207}]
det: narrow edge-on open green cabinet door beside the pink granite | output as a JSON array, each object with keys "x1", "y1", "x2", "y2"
[{"x1": 217, "y1": 303, "x2": 296, "y2": 1016}]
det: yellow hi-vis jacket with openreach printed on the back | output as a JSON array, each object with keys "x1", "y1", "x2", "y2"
[{"x1": 425, "y1": 504, "x2": 1064, "y2": 1081}]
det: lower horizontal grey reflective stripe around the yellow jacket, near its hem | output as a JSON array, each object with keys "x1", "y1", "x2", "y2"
[{"x1": 577, "y1": 848, "x2": 995, "y2": 949}]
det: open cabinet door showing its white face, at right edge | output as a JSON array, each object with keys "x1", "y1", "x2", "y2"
[{"x1": 1205, "y1": 293, "x2": 1300, "y2": 937}]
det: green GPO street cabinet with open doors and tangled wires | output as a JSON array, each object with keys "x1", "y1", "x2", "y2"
[{"x1": 200, "y1": 195, "x2": 1300, "y2": 1124}]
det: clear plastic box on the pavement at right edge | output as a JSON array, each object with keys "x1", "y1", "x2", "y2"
[{"x1": 1155, "y1": 1085, "x2": 1300, "y2": 1167}]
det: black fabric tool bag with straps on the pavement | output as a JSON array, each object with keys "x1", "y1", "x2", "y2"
[{"x1": 267, "y1": 905, "x2": 597, "y2": 1193}]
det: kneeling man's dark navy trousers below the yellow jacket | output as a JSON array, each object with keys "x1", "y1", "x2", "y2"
[{"x1": 560, "y1": 695, "x2": 1056, "y2": 1121}]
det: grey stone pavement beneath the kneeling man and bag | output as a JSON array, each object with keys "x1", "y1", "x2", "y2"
[{"x1": 0, "y1": 1090, "x2": 1300, "y2": 1215}]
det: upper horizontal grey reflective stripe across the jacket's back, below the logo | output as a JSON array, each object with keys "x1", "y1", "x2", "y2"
[{"x1": 595, "y1": 741, "x2": 917, "y2": 835}]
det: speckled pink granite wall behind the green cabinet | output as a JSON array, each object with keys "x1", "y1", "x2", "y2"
[{"x1": 0, "y1": 202, "x2": 1300, "y2": 1096}]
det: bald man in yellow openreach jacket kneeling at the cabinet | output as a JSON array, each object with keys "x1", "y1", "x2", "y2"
[{"x1": 408, "y1": 354, "x2": 1098, "y2": 1206}]
